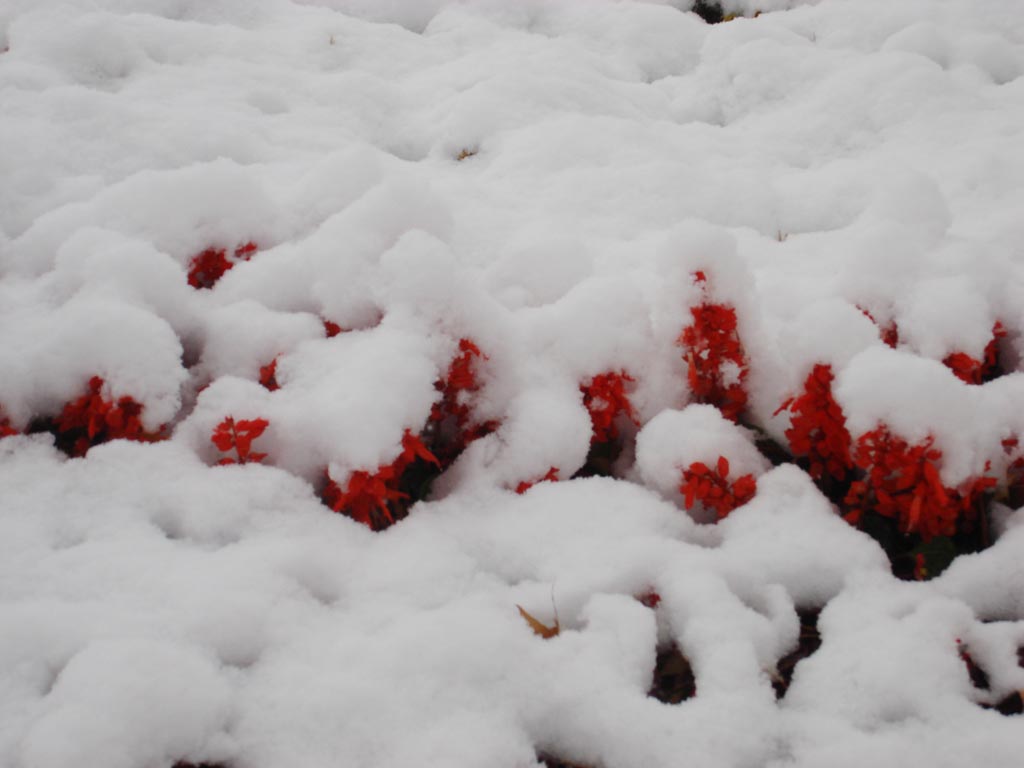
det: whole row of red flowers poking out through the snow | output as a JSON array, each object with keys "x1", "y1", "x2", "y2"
[{"x1": 0, "y1": 259, "x2": 1024, "y2": 578}]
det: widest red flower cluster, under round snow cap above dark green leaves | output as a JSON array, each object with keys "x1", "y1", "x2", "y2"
[{"x1": 845, "y1": 425, "x2": 995, "y2": 542}]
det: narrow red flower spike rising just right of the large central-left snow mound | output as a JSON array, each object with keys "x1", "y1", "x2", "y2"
[{"x1": 430, "y1": 339, "x2": 498, "y2": 467}]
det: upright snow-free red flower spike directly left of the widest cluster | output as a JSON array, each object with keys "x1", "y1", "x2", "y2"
[{"x1": 775, "y1": 364, "x2": 853, "y2": 482}]
